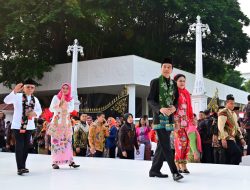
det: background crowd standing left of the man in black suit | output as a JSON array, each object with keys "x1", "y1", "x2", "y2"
[{"x1": 1, "y1": 112, "x2": 152, "y2": 160}]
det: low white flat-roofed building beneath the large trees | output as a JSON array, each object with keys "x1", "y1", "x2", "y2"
[{"x1": 0, "y1": 55, "x2": 248, "y2": 120}]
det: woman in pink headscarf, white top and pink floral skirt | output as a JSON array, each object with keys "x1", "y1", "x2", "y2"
[{"x1": 48, "y1": 83, "x2": 80, "y2": 169}]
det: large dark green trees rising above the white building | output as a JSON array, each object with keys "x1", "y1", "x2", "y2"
[{"x1": 0, "y1": 0, "x2": 250, "y2": 88}]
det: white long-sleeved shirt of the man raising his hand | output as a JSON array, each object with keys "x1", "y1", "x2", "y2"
[{"x1": 4, "y1": 91, "x2": 42, "y2": 130}]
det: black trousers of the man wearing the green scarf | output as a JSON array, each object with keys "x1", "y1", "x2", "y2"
[{"x1": 150, "y1": 129, "x2": 178, "y2": 174}]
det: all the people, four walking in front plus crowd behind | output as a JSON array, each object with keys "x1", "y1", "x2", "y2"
[{"x1": 0, "y1": 59, "x2": 250, "y2": 181}]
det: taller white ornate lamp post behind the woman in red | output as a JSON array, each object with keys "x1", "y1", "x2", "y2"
[{"x1": 187, "y1": 15, "x2": 211, "y2": 114}]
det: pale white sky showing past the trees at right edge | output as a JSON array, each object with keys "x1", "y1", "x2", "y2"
[{"x1": 236, "y1": 0, "x2": 250, "y2": 73}]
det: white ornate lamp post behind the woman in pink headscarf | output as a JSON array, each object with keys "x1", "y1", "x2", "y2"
[{"x1": 67, "y1": 39, "x2": 84, "y2": 111}]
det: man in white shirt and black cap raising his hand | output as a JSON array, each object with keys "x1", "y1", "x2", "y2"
[{"x1": 4, "y1": 79, "x2": 42, "y2": 175}]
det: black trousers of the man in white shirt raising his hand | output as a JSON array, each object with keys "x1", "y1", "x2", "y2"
[{"x1": 13, "y1": 129, "x2": 32, "y2": 169}]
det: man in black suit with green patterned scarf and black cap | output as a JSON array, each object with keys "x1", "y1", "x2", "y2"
[{"x1": 147, "y1": 58, "x2": 183, "y2": 181}]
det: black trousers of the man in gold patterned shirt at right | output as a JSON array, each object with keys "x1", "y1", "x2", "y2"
[{"x1": 225, "y1": 140, "x2": 242, "y2": 165}]
